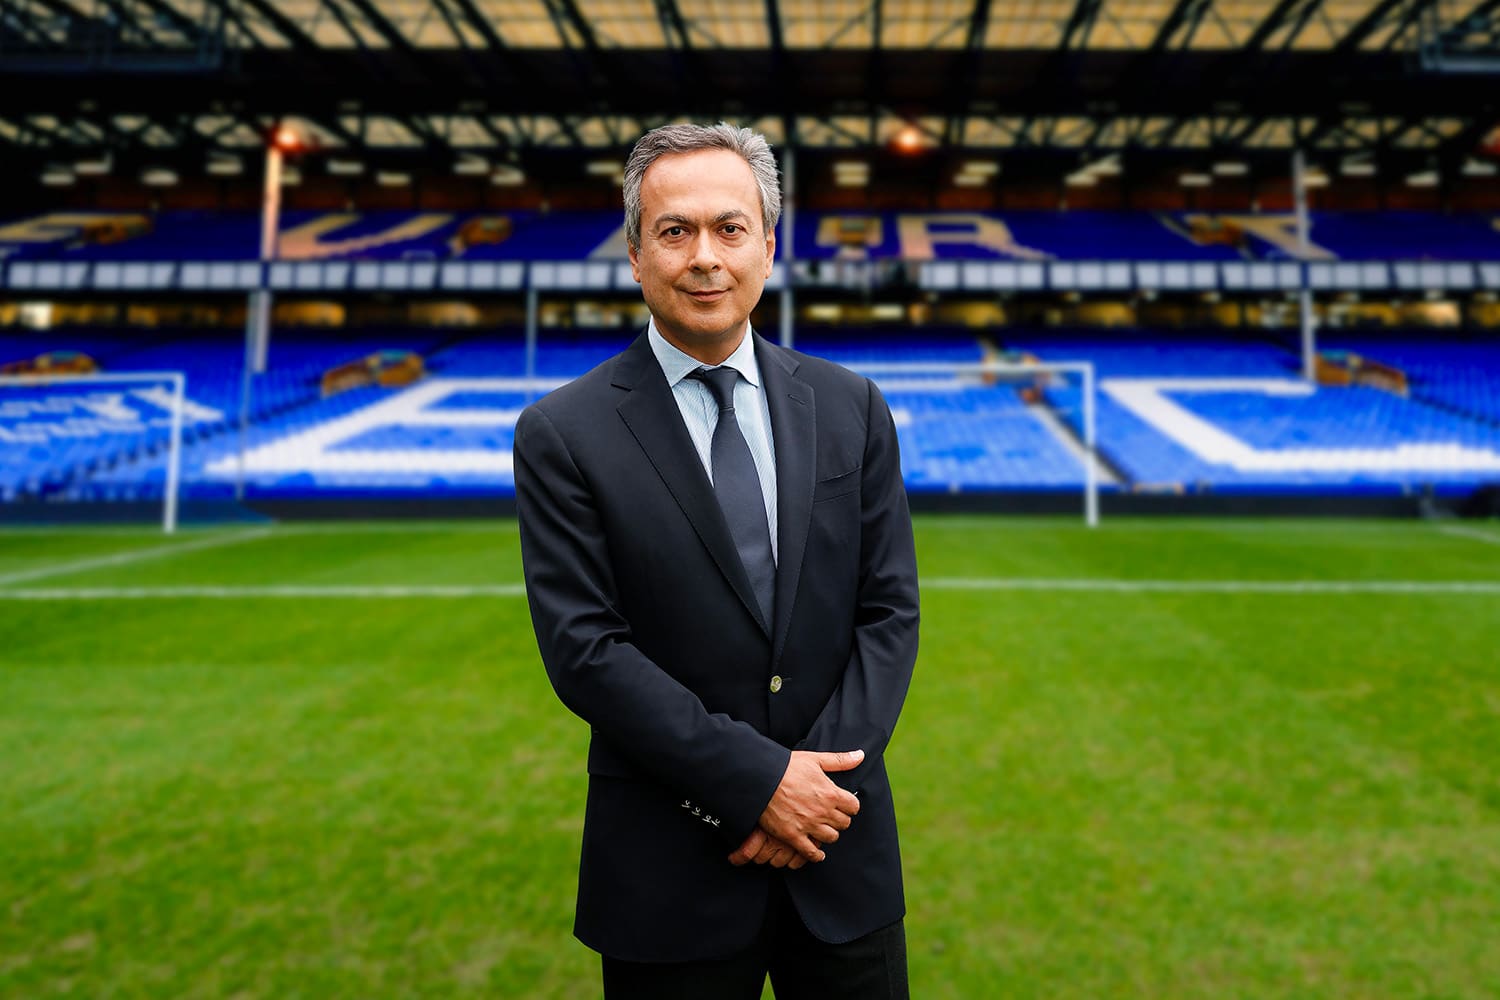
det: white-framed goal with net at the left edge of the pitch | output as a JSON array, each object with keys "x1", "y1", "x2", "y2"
[{"x1": 0, "y1": 372, "x2": 188, "y2": 534}]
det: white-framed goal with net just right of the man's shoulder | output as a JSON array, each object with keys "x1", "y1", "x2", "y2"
[{"x1": 843, "y1": 361, "x2": 1110, "y2": 526}]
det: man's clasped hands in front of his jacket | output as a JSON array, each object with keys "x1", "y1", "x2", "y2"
[{"x1": 729, "y1": 750, "x2": 864, "y2": 871}]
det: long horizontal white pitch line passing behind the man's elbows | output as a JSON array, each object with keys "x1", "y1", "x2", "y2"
[{"x1": 0, "y1": 577, "x2": 1500, "y2": 601}]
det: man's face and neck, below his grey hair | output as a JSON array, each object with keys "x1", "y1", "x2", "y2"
[{"x1": 630, "y1": 150, "x2": 776, "y2": 364}]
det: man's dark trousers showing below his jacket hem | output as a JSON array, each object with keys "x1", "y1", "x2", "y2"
[{"x1": 603, "y1": 873, "x2": 911, "y2": 1000}]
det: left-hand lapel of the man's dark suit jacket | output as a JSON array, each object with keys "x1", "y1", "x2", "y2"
[{"x1": 612, "y1": 334, "x2": 780, "y2": 636}]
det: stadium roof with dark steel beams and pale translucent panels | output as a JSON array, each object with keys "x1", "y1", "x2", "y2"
[{"x1": 0, "y1": 0, "x2": 1500, "y2": 179}]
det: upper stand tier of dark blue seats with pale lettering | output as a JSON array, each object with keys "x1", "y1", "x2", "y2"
[{"x1": 0, "y1": 211, "x2": 1500, "y2": 262}]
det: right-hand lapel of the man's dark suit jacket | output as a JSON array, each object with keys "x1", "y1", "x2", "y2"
[{"x1": 756, "y1": 336, "x2": 818, "y2": 666}]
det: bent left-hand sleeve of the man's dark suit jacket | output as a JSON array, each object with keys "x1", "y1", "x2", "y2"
[{"x1": 515, "y1": 406, "x2": 791, "y2": 844}]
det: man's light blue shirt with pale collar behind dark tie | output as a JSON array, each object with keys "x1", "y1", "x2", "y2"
[{"x1": 647, "y1": 319, "x2": 780, "y2": 559}]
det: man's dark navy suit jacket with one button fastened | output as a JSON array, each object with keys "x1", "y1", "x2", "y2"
[{"x1": 515, "y1": 334, "x2": 918, "y2": 961}]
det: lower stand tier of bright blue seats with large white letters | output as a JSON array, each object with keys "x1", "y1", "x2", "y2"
[{"x1": 0, "y1": 328, "x2": 1500, "y2": 501}]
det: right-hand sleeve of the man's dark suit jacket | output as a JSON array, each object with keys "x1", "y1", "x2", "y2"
[{"x1": 797, "y1": 382, "x2": 920, "y2": 790}]
